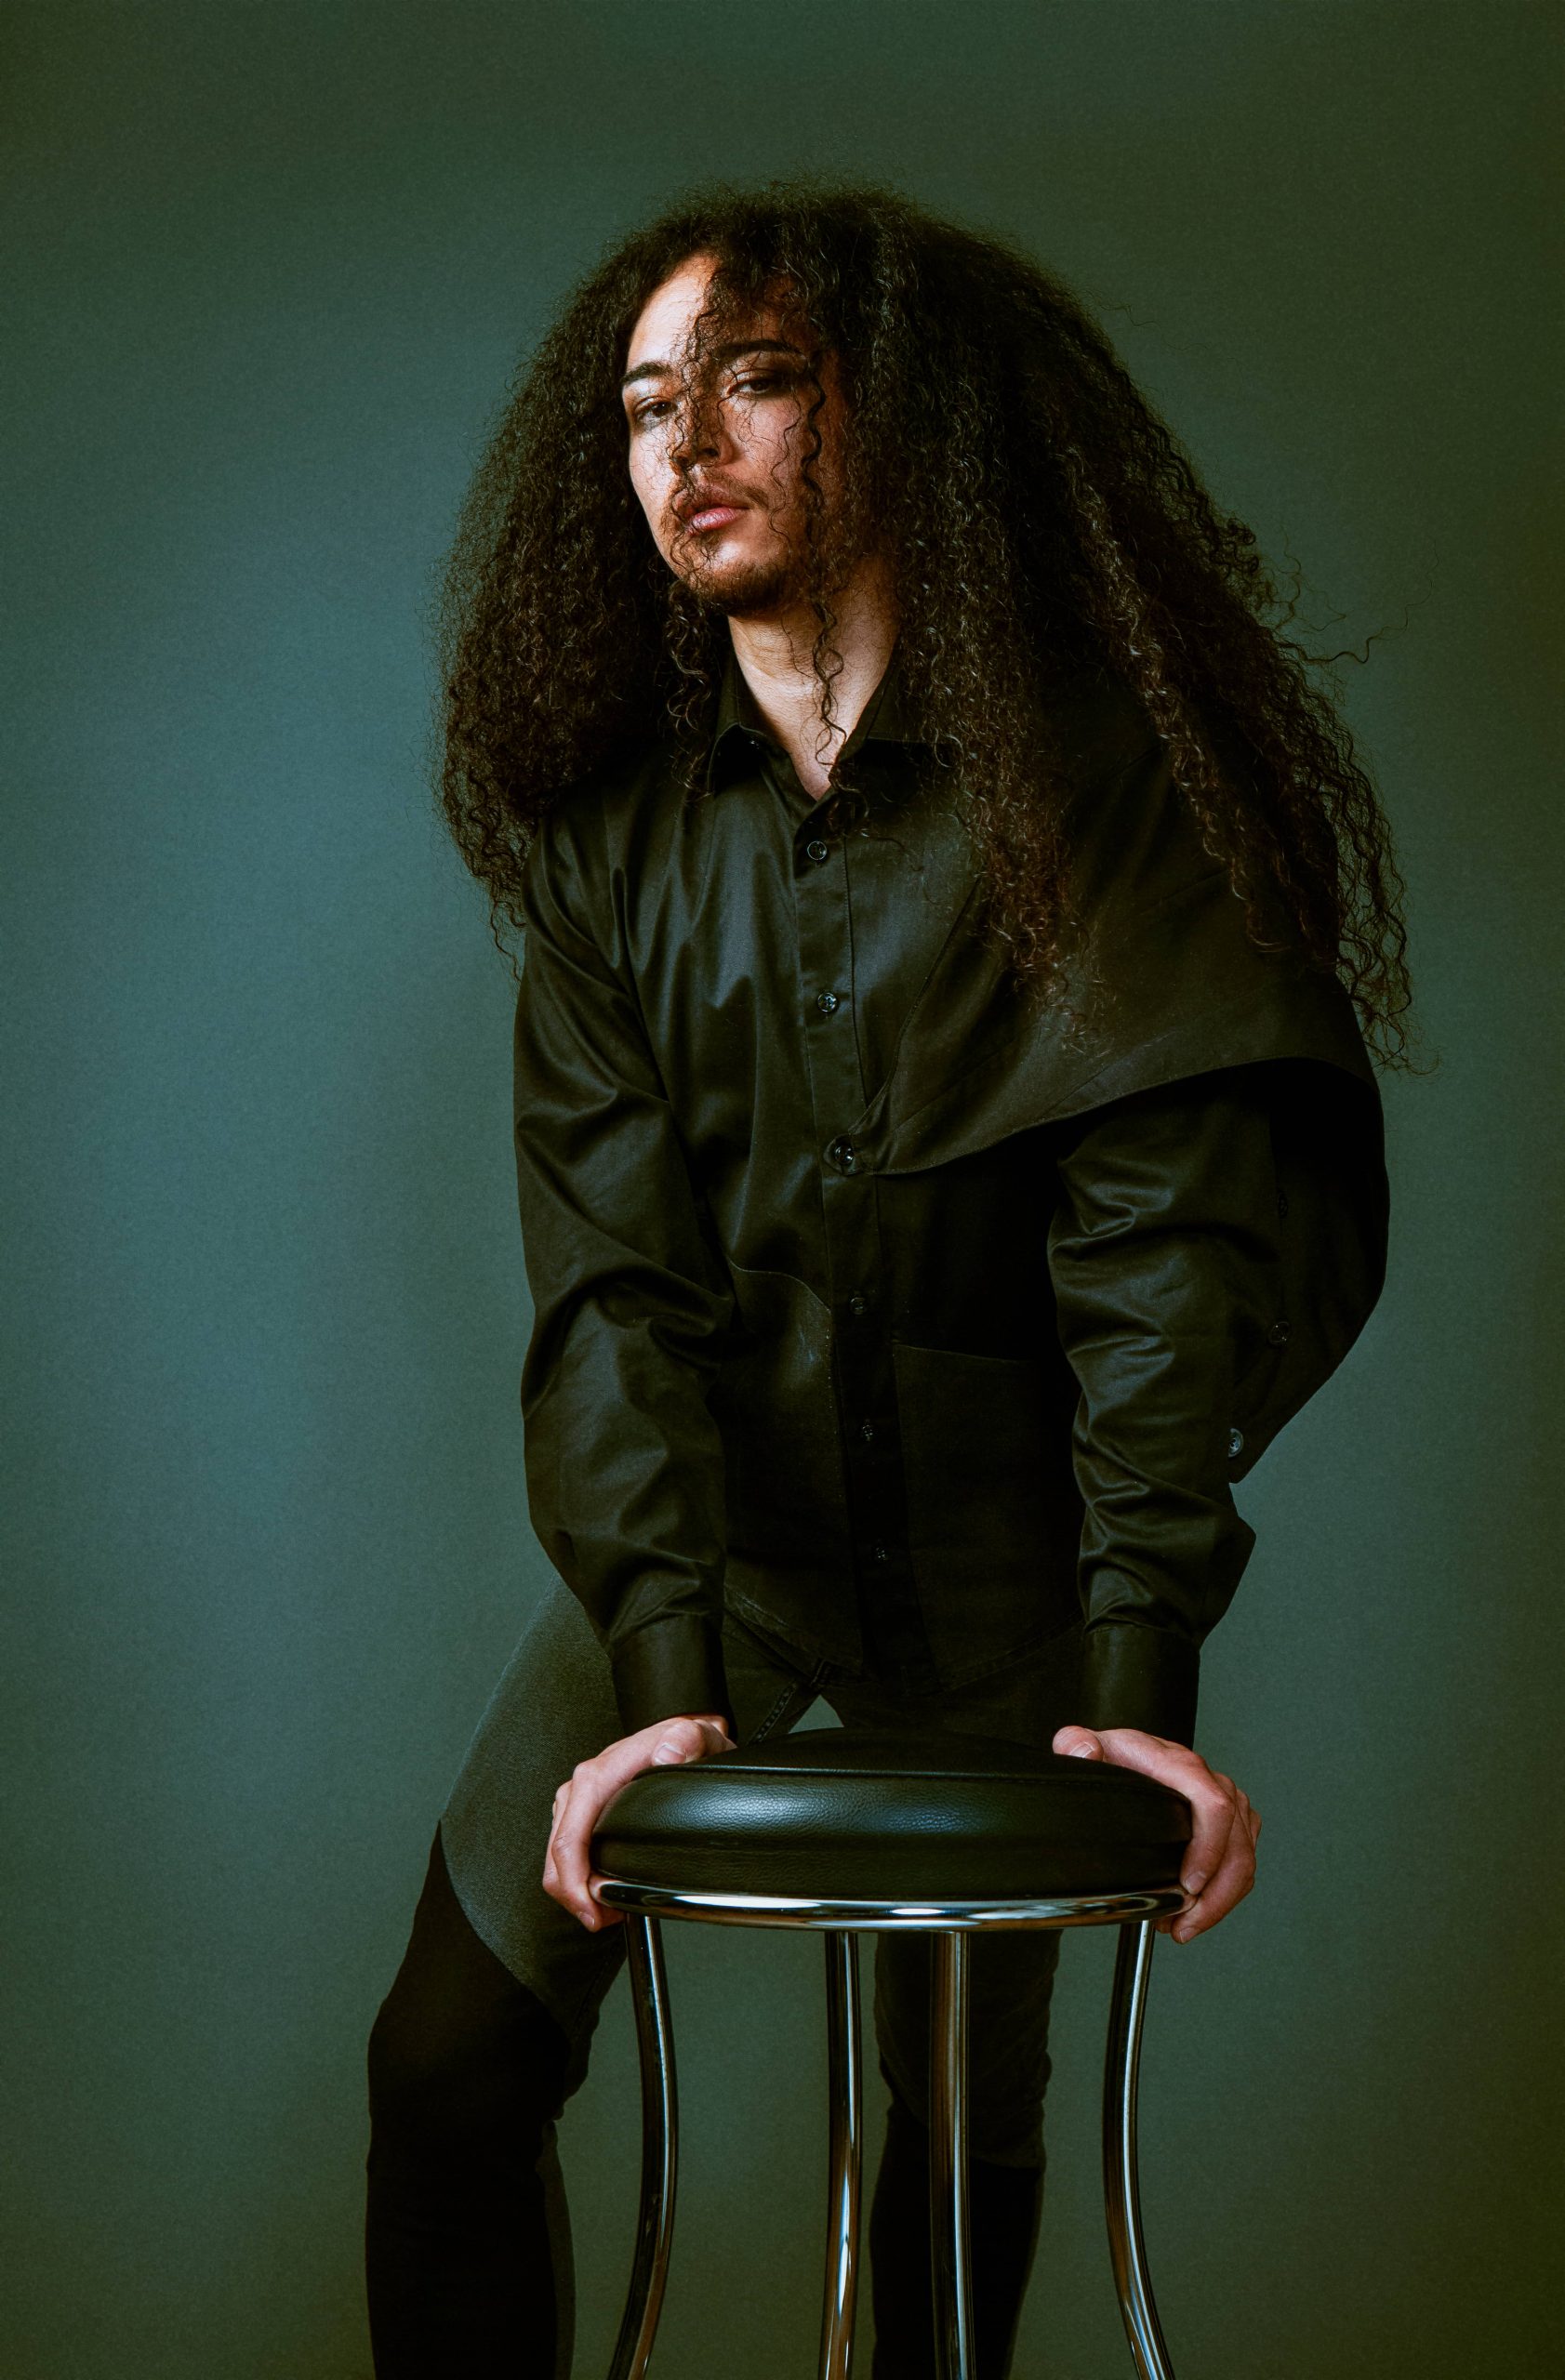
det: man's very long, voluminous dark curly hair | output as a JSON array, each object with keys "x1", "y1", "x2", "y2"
[{"x1": 438, "y1": 183, "x2": 1410, "y2": 1064}]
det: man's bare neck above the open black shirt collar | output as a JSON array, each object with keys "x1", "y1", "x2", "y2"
[{"x1": 729, "y1": 557, "x2": 895, "y2": 800}]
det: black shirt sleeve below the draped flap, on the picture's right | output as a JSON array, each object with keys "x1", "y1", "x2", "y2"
[{"x1": 1048, "y1": 1066, "x2": 1286, "y2": 1742}]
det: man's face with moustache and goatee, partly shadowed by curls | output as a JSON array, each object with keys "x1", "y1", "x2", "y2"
[{"x1": 624, "y1": 255, "x2": 843, "y2": 616}]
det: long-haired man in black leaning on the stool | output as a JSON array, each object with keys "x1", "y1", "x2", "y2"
[{"x1": 366, "y1": 191, "x2": 1405, "y2": 2380}]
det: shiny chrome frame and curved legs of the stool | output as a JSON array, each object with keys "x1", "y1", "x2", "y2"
[{"x1": 592, "y1": 1878, "x2": 1184, "y2": 2380}]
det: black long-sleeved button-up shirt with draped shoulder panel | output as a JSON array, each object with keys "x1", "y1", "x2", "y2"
[{"x1": 502, "y1": 642, "x2": 1384, "y2": 1738}]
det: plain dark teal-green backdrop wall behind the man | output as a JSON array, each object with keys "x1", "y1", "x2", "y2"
[{"x1": 0, "y1": 0, "x2": 1560, "y2": 2380}]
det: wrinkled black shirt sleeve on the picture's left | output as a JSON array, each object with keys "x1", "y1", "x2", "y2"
[{"x1": 514, "y1": 821, "x2": 731, "y2": 1735}]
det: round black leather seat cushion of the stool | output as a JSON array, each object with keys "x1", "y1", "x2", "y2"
[{"x1": 593, "y1": 1728, "x2": 1191, "y2": 1901}]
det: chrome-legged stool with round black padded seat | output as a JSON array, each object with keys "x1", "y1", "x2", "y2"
[{"x1": 593, "y1": 1728, "x2": 1191, "y2": 2380}]
